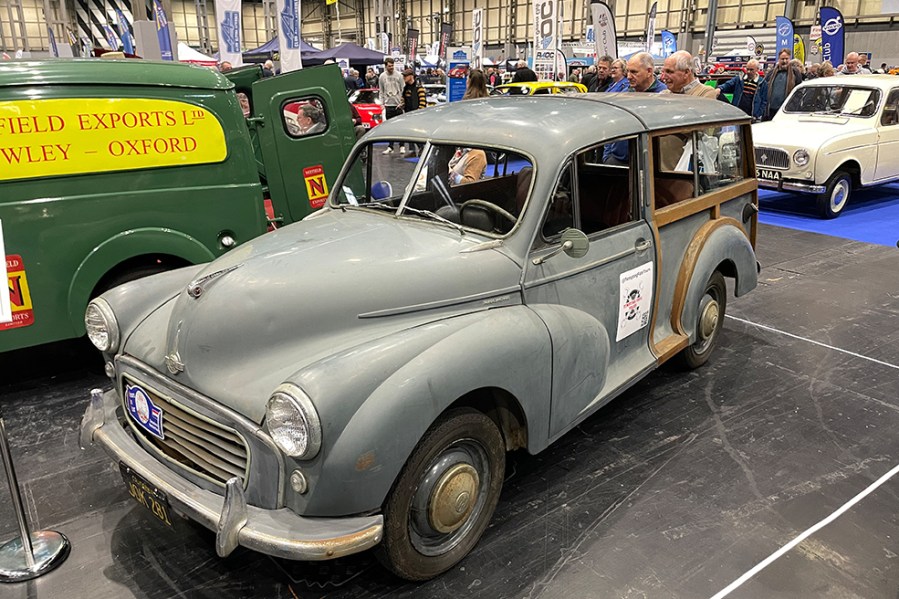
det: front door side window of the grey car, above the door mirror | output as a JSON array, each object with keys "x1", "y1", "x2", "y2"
[{"x1": 575, "y1": 138, "x2": 638, "y2": 235}]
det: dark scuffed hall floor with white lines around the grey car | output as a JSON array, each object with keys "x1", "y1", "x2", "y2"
[{"x1": 0, "y1": 226, "x2": 899, "y2": 599}]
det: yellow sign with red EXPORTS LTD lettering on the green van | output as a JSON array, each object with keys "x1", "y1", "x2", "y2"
[{"x1": 0, "y1": 98, "x2": 228, "y2": 181}]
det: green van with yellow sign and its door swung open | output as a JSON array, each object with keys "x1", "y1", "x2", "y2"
[{"x1": 0, "y1": 60, "x2": 355, "y2": 352}]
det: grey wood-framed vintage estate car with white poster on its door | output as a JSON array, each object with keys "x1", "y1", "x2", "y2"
[{"x1": 81, "y1": 94, "x2": 758, "y2": 580}]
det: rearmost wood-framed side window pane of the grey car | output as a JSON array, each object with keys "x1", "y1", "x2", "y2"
[{"x1": 696, "y1": 125, "x2": 744, "y2": 195}]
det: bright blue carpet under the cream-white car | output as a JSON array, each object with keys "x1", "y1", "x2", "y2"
[{"x1": 759, "y1": 183, "x2": 899, "y2": 247}]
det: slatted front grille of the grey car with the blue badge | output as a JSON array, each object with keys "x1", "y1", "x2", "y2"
[{"x1": 122, "y1": 379, "x2": 250, "y2": 486}]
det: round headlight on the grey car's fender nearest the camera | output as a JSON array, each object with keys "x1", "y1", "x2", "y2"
[{"x1": 265, "y1": 383, "x2": 322, "y2": 460}]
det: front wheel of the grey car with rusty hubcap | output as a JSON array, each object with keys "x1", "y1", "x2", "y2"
[{"x1": 377, "y1": 409, "x2": 506, "y2": 580}]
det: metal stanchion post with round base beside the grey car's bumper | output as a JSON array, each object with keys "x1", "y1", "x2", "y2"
[{"x1": 0, "y1": 411, "x2": 70, "y2": 582}]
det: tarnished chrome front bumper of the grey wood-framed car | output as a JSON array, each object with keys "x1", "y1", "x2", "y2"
[{"x1": 81, "y1": 390, "x2": 384, "y2": 561}]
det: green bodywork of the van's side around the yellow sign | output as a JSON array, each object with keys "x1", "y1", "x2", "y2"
[{"x1": 0, "y1": 79, "x2": 266, "y2": 352}]
